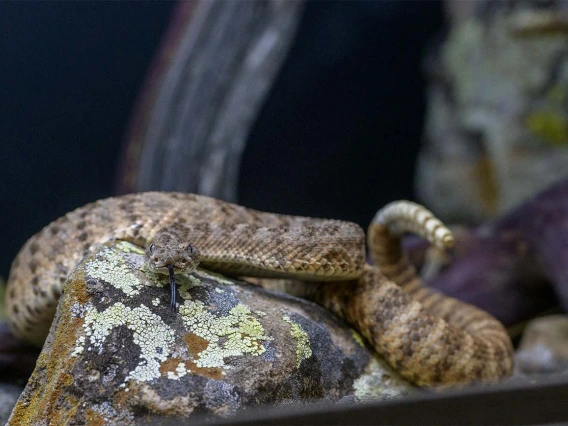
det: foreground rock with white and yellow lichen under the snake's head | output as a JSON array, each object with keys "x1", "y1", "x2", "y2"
[{"x1": 6, "y1": 242, "x2": 412, "y2": 425}]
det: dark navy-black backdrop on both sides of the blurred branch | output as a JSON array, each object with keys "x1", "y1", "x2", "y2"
[{"x1": 0, "y1": 1, "x2": 442, "y2": 277}]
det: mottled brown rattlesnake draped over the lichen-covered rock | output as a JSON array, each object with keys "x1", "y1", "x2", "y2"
[{"x1": 6, "y1": 192, "x2": 512, "y2": 386}]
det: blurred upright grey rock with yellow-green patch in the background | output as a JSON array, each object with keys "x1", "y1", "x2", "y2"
[{"x1": 415, "y1": 0, "x2": 568, "y2": 223}]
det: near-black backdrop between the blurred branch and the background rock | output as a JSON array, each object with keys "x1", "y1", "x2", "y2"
[{"x1": 239, "y1": 1, "x2": 442, "y2": 229}]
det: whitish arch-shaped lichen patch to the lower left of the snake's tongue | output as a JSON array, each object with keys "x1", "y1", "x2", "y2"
[{"x1": 74, "y1": 302, "x2": 174, "y2": 382}]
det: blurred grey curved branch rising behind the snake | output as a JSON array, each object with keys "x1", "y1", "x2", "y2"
[{"x1": 119, "y1": 0, "x2": 303, "y2": 200}]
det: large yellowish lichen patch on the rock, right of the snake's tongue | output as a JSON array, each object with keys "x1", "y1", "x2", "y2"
[{"x1": 179, "y1": 300, "x2": 269, "y2": 368}]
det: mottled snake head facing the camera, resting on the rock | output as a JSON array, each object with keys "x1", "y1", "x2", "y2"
[{"x1": 146, "y1": 232, "x2": 200, "y2": 275}]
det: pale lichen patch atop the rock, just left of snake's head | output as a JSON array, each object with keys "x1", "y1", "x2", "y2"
[{"x1": 85, "y1": 247, "x2": 142, "y2": 296}]
